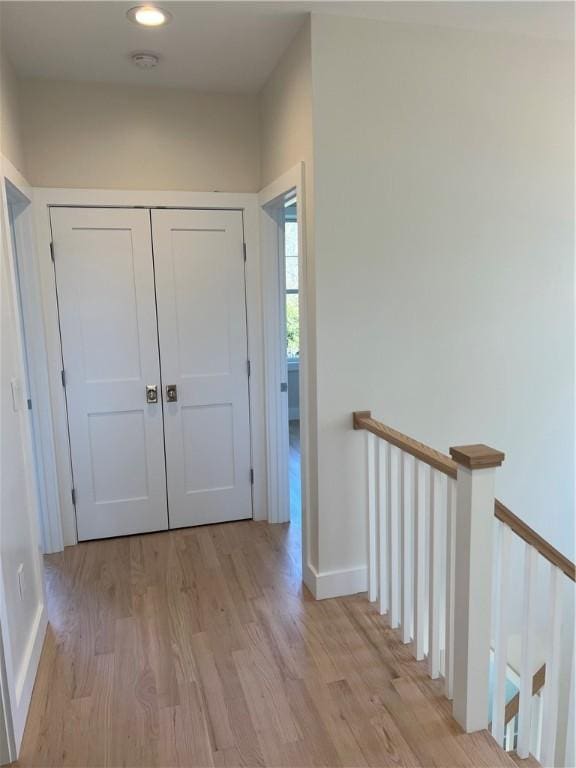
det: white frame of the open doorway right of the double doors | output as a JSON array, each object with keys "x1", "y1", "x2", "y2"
[{"x1": 258, "y1": 162, "x2": 310, "y2": 560}]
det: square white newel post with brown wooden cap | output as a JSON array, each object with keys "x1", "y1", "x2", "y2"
[{"x1": 450, "y1": 445, "x2": 504, "y2": 733}]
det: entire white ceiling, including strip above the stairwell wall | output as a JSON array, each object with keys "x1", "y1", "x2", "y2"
[{"x1": 0, "y1": 0, "x2": 574, "y2": 93}]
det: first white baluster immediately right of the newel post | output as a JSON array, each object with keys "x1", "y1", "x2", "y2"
[{"x1": 492, "y1": 523, "x2": 510, "y2": 744}]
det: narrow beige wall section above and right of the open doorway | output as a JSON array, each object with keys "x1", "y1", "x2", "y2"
[{"x1": 259, "y1": 21, "x2": 318, "y2": 570}]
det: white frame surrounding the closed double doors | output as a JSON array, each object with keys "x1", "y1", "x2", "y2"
[{"x1": 32, "y1": 188, "x2": 267, "y2": 546}]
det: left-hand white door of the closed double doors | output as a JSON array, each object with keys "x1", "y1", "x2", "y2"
[{"x1": 51, "y1": 208, "x2": 168, "y2": 540}]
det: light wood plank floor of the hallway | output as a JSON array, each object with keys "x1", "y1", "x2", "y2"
[{"x1": 19, "y1": 522, "x2": 514, "y2": 768}]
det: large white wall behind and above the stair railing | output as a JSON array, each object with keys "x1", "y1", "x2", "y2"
[{"x1": 312, "y1": 16, "x2": 574, "y2": 570}]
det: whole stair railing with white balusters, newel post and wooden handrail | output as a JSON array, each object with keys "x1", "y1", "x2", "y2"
[{"x1": 353, "y1": 411, "x2": 575, "y2": 765}]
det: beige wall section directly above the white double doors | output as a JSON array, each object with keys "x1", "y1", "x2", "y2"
[{"x1": 22, "y1": 80, "x2": 259, "y2": 192}]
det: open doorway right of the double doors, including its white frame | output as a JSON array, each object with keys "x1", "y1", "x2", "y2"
[{"x1": 259, "y1": 163, "x2": 313, "y2": 584}]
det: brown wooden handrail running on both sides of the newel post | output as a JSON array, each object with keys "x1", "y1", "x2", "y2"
[{"x1": 353, "y1": 411, "x2": 576, "y2": 581}]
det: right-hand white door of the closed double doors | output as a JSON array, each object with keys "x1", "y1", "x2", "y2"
[{"x1": 152, "y1": 210, "x2": 252, "y2": 528}]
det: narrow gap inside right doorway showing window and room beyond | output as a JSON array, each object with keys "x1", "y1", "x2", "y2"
[{"x1": 282, "y1": 194, "x2": 302, "y2": 528}]
